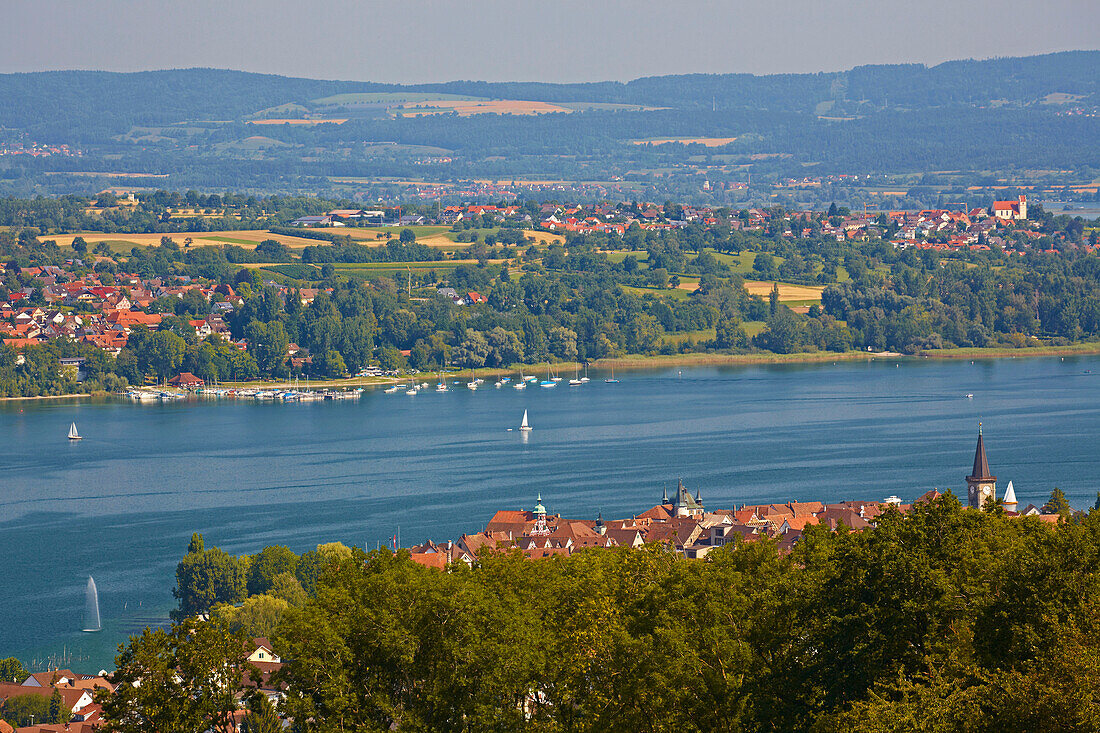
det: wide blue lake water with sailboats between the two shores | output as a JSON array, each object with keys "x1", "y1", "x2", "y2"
[{"x1": 0, "y1": 358, "x2": 1100, "y2": 671}]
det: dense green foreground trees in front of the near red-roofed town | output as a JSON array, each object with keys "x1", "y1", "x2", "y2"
[{"x1": 94, "y1": 493, "x2": 1100, "y2": 733}]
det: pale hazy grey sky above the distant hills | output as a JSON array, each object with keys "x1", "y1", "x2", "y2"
[{"x1": 0, "y1": 0, "x2": 1100, "y2": 81}]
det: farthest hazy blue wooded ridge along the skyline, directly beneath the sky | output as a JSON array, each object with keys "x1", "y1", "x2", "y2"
[{"x1": 0, "y1": 51, "x2": 1100, "y2": 139}]
